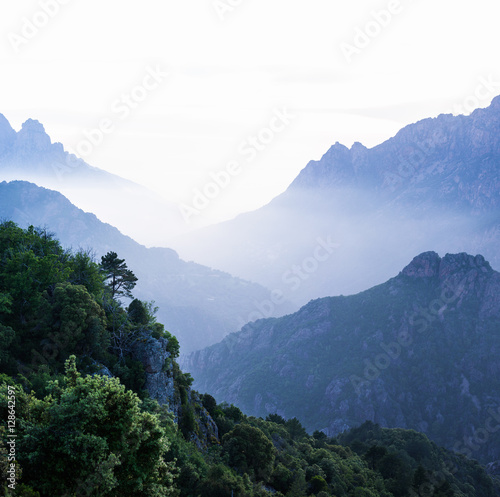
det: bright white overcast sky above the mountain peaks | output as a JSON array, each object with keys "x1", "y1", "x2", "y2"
[{"x1": 0, "y1": 0, "x2": 500, "y2": 225}]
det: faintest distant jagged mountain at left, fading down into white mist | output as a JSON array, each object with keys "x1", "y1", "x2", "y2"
[{"x1": 0, "y1": 114, "x2": 189, "y2": 246}]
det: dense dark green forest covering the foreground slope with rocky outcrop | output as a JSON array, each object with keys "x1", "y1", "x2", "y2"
[{"x1": 0, "y1": 221, "x2": 500, "y2": 497}]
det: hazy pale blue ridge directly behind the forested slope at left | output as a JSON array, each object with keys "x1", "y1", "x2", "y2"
[{"x1": 0, "y1": 181, "x2": 293, "y2": 353}]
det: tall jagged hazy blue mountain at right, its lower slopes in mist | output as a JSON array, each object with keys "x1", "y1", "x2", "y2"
[{"x1": 172, "y1": 97, "x2": 500, "y2": 305}]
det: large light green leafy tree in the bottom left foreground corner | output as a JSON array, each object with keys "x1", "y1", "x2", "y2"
[{"x1": 19, "y1": 356, "x2": 174, "y2": 497}]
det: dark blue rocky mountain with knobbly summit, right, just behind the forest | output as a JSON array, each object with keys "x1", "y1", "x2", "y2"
[{"x1": 183, "y1": 252, "x2": 500, "y2": 463}]
